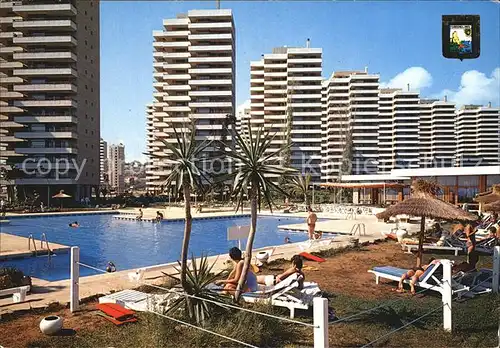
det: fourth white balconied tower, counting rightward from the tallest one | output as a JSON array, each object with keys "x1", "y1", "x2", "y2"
[{"x1": 377, "y1": 89, "x2": 420, "y2": 173}]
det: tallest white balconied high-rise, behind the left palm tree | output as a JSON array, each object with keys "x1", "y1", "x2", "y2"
[{"x1": 147, "y1": 9, "x2": 236, "y2": 190}]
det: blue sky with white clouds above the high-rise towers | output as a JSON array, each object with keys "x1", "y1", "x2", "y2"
[{"x1": 100, "y1": 1, "x2": 500, "y2": 160}]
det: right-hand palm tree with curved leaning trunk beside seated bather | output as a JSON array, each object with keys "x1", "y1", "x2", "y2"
[{"x1": 221, "y1": 122, "x2": 295, "y2": 301}]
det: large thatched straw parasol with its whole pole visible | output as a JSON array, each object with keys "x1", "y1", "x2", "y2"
[{"x1": 376, "y1": 180, "x2": 478, "y2": 267}]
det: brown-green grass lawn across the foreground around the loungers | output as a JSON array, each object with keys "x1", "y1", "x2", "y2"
[{"x1": 0, "y1": 242, "x2": 500, "y2": 348}]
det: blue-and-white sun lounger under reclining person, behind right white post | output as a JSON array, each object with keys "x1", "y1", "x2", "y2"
[{"x1": 368, "y1": 262, "x2": 469, "y2": 293}]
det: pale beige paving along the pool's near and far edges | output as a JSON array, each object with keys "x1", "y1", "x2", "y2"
[{"x1": 0, "y1": 209, "x2": 418, "y2": 314}]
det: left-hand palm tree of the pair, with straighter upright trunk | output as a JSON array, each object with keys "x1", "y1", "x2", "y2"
[{"x1": 149, "y1": 124, "x2": 211, "y2": 293}]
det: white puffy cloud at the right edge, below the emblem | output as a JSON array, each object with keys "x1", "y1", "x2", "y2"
[{"x1": 436, "y1": 68, "x2": 500, "y2": 106}]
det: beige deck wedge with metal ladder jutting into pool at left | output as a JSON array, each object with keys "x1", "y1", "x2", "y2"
[{"x1": 0, "y1": 233, "x2": 70, "y2": 260}]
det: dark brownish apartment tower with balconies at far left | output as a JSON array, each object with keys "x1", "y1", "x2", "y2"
[{"x1": 0, "y1": 0, "x2": 100, "y2": 204}]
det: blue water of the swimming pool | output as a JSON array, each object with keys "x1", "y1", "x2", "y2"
[{"x1": 0, "y1": 215, "x2": 307, "y2": 281}]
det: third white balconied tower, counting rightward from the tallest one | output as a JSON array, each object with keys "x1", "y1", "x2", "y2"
[{"x1": 322, "y1": 69, "x2": 379, "y2": 181}]
